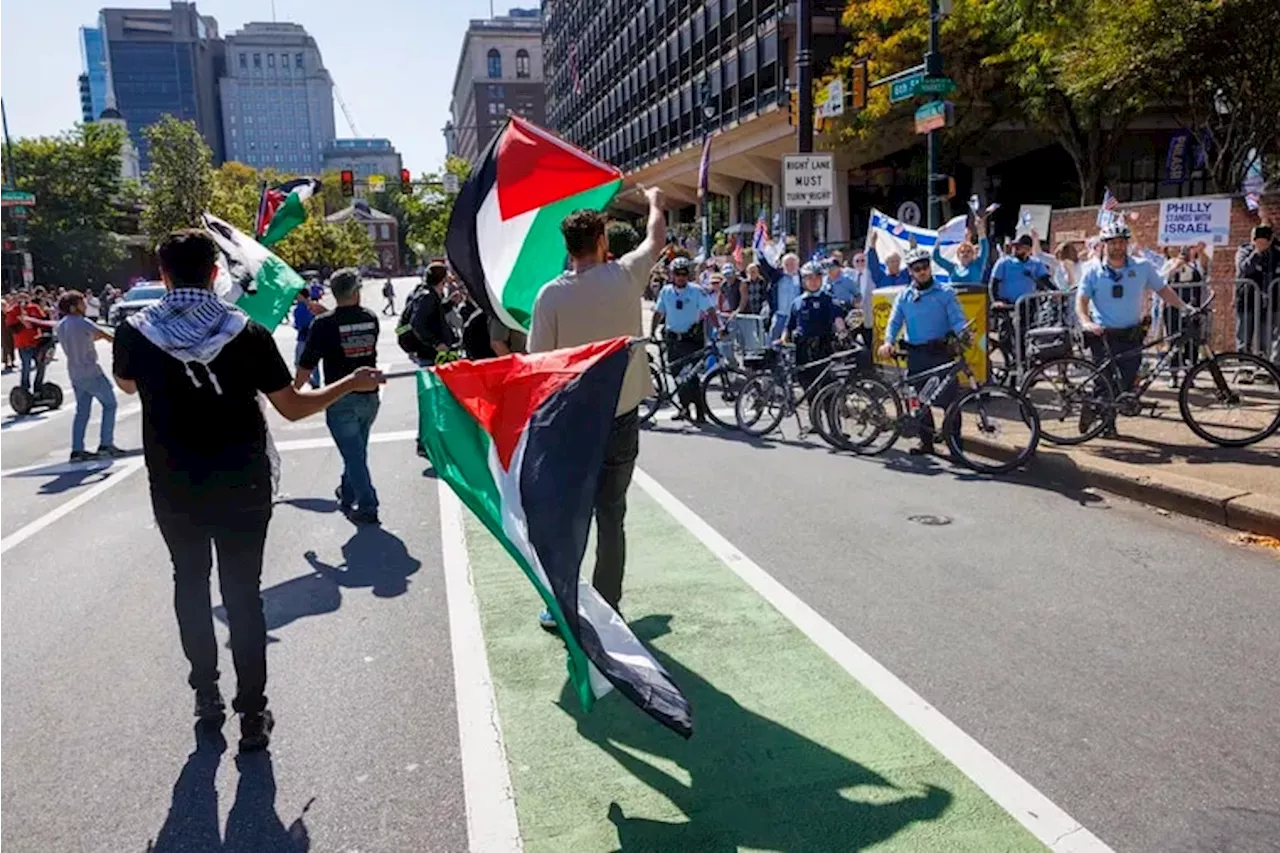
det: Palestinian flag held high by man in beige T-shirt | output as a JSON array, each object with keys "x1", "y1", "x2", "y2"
[{"x1": 444, "y1": 117, "x2": 622, "y2": 330}]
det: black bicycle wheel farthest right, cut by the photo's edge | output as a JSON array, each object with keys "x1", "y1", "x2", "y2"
[{"x1": 1178, "y1": 352, "x2": 1280, "y2": 447}]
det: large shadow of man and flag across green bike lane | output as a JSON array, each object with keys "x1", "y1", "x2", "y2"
[{"x1": 559, "y1": 616, "x2": 952, "y2": 853}]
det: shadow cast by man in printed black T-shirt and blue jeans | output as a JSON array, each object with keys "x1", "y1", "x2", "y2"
[{"x1": 214, "y1": 525, "x2": 422, "y2": 643}]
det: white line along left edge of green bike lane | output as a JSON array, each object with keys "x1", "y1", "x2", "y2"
[{"x1": 439, "y1": 480, "x2": 524, "y2": 853}]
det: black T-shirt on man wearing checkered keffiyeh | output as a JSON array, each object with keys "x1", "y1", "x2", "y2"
[{"x1": 113, "y1": 320, "x2": 292, "y2": 514}]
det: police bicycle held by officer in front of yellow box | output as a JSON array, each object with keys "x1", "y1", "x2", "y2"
[{"x1": 827, "y1": 320, "x2": 1041, "y2": 474}]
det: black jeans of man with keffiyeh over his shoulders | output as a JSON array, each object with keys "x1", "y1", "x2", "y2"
[{"x1": 156, "y1": 507, "x2": 271, "y2": 713}]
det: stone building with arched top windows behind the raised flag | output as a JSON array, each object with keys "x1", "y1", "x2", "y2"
[{"x1": 444, "y1": 9, "x2": 547, "y2": 161}]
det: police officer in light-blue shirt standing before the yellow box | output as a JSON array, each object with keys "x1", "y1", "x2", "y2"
[{"x1": 879, "y1": 247, "x2": 965, "y2": 456}]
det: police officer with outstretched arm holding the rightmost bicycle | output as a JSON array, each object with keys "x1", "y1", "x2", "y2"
[{"x1": 1075, "y1": 220, "x2": 1192, "y2": 435}]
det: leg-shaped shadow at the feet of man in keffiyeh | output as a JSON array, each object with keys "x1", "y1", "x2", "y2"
[{"x1": 147, "y1": 726, "x2": 314, "y2": 853}]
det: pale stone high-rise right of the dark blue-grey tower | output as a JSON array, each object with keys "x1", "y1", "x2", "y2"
[{"x1": 220, "y1": 23, "x2": 337, "y2": 173}]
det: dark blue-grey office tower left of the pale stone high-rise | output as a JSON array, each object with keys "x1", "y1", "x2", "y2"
[{"x1": 90, "y1": 1, "x2": 224, "y2": 170}]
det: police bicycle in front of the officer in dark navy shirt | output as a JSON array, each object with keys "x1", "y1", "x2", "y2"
[{"x1": 733, "y1": 333, "x2": 864, "y2": 448}]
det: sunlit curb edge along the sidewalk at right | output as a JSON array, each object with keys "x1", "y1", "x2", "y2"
[{"x1": 965, "y1": 435, "x2": 1280, "y2": 538}]
